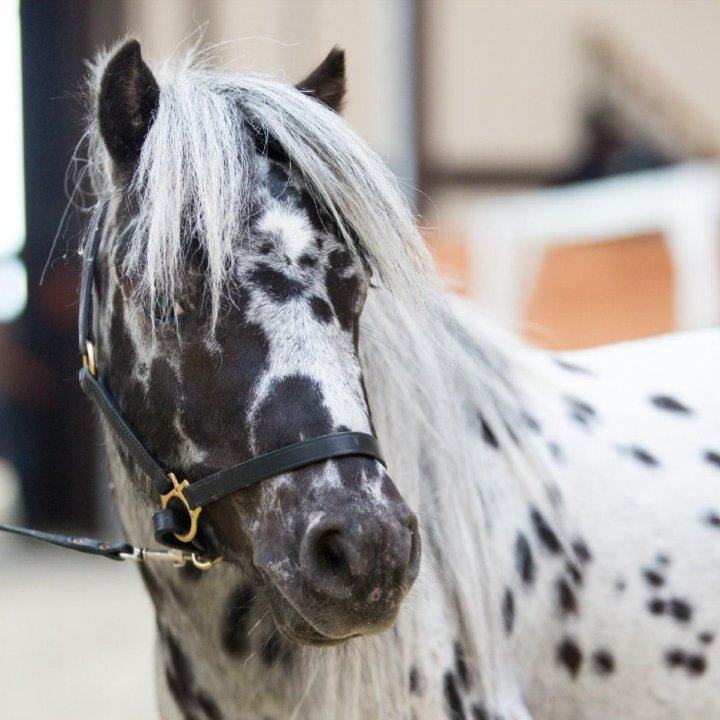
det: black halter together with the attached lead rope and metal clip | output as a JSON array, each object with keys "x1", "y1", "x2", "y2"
[{"x1": 0, "y1": 202, "x2": 385, "y2": 570}]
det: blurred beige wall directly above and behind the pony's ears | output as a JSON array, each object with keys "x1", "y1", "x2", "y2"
[{"x1": 98, "y1": 0, "x2": 415, "y2": 188}]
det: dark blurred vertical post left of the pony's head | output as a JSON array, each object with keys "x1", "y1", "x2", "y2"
[{"x1": 16, "y1": 0, "x2": 122, "y2": 530}]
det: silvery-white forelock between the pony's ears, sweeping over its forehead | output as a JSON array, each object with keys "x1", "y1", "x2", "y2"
[{"x1": 88, "y1": 46, "x2": 439, "y2": 334}]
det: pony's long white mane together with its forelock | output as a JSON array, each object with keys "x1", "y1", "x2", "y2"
[{"x1": 81, "y1": 46, "x2": 552, "y2": 717}]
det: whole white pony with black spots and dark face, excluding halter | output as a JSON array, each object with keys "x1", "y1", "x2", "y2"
[{"x1": 81, "y1": 40, "x2": 720, "y2": 720}]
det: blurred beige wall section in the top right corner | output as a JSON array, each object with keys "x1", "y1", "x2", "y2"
[{"x1": 423, "y1": 0, "x2": 720, "y2": 177}]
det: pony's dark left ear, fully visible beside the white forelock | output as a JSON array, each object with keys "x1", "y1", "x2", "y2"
[{"x1": 98, "y1": 40, "x2": 160, "y2": 168}]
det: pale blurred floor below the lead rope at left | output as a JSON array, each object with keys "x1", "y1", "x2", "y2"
[{"x1": 0, "y1": 536, "x2": 157, "y2": 720}]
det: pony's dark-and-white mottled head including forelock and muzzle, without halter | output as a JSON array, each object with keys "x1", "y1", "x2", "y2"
[{"x1": 91, "y1": 41, "x2": 420, "y2": 645}]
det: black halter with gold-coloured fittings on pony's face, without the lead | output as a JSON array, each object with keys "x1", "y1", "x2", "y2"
[{"x1": 79, "y1": 204, "x2": 385, "y2": 551}]
